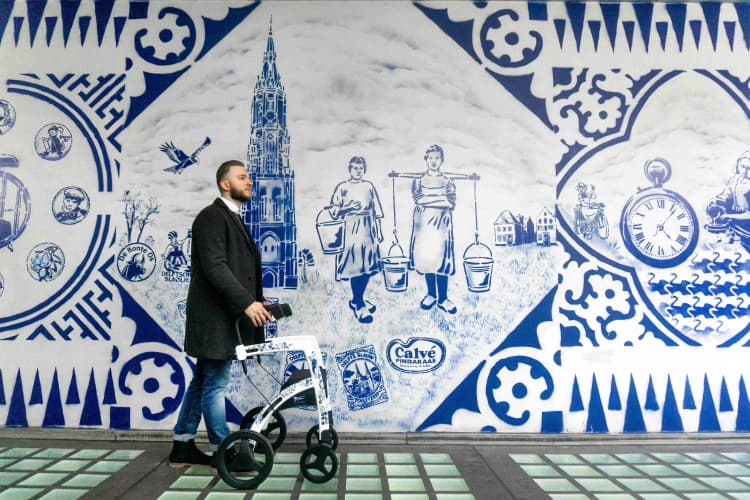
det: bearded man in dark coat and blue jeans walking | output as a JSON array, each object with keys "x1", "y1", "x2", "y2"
[{"x1": 169, "y1": 160, "x2": 273, "y2": 467}]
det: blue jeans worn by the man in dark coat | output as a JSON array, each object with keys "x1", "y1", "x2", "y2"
[{"x1": 174, "y1": 358, "x2": 232, "y2": 447}]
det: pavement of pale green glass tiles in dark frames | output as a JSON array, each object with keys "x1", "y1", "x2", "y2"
[{"x1": 0, "y1": 436, "x2": 750, "y2": 500}]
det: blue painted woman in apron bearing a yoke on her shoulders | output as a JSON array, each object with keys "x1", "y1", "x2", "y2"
[{"x1": 410, "y1": 144, "x2": 456, "y2": 314}]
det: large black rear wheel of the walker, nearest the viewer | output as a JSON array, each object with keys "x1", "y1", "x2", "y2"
[{"x1": 216, "y1": 429, "x2": 273, "y2": 490}]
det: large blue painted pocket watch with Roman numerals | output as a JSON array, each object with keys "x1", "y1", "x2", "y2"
[{"x1": 620, "y1": 158, "x2": 698, "y2": 268}]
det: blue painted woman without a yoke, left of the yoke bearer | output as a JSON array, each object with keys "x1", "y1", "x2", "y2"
[{"x1": 329, "y1": 156, "x2": 383, "y2": 323}]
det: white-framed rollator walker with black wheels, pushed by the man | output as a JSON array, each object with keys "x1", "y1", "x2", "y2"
[{"x1": 216, "y1": 312, "x2": 338, "y2": 489}]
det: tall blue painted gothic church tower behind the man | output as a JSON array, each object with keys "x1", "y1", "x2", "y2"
[{"x1": 243, "y1": 20, "x2": 297, "y2": 288}]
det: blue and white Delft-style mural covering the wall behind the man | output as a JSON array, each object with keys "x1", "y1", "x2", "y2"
[{"x1": 0, "y1": 0, "x2": 750, "y2": 433}]
